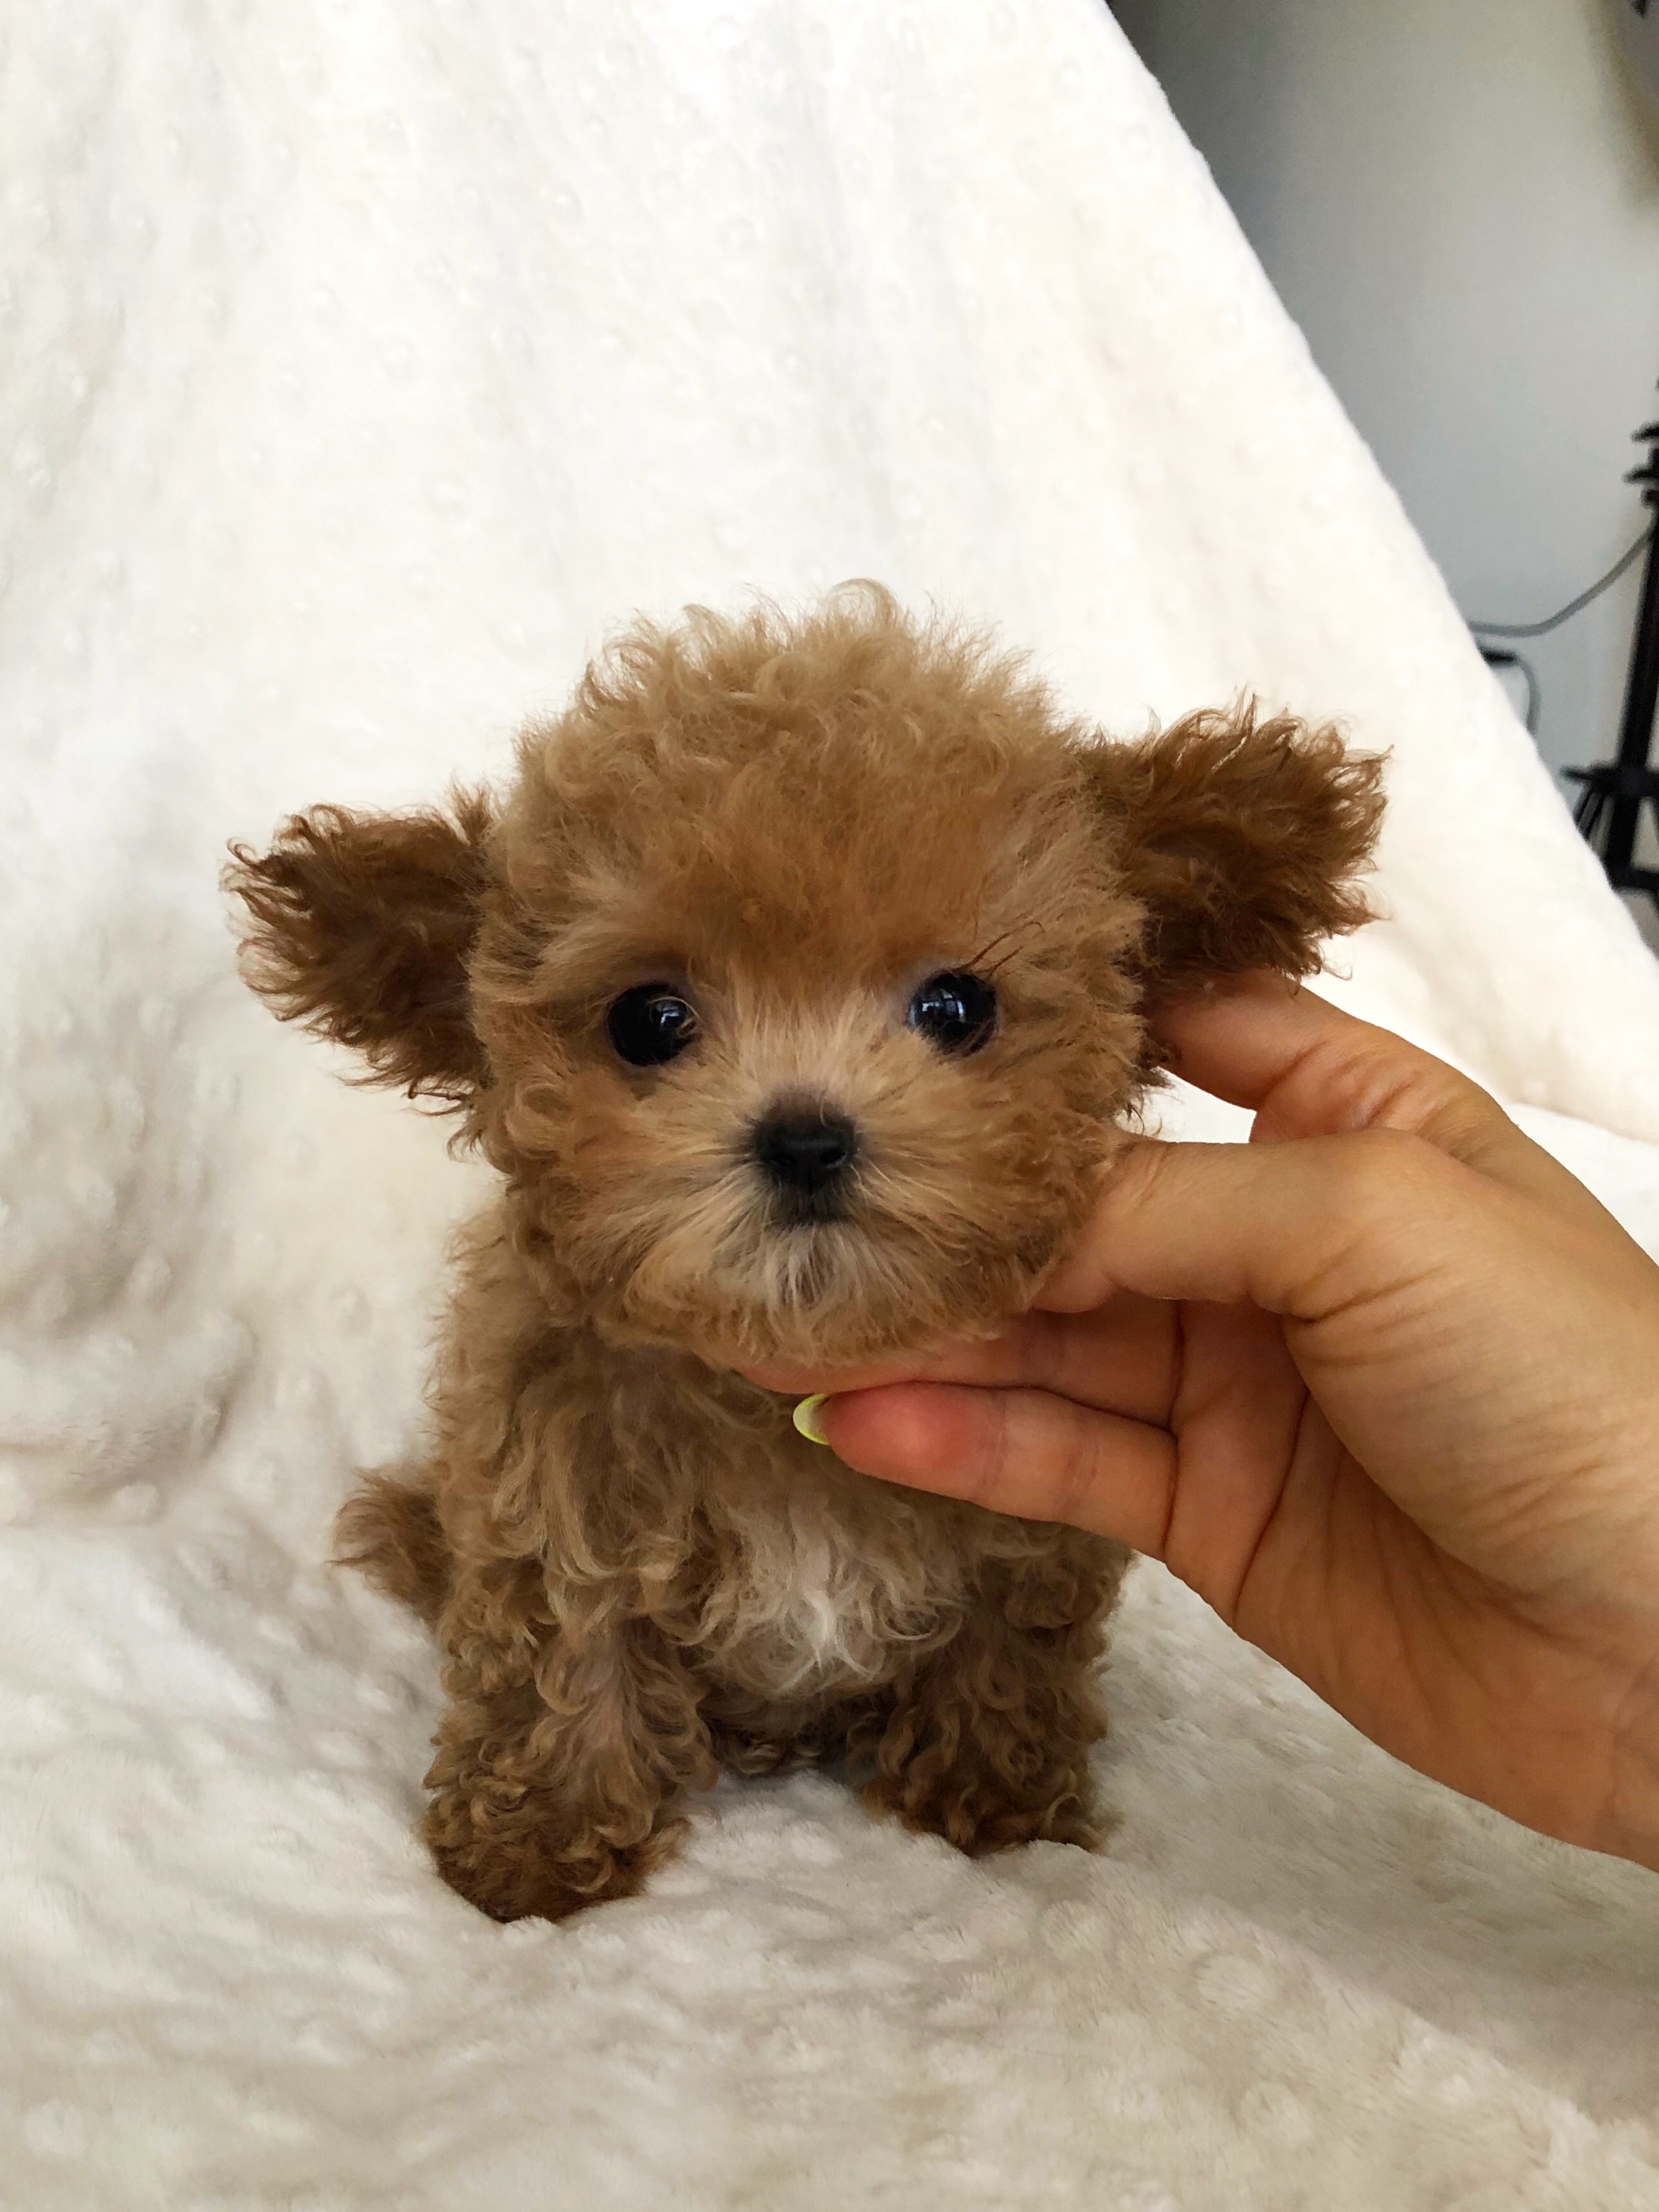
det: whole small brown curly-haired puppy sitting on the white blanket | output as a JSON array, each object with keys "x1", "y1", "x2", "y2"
[{"x1": 228, "y1": 586, "x2": 1380, "y2": 1920}]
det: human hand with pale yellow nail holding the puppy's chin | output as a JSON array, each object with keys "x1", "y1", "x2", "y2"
[{"x1": 754, "y1": 978, "x2": 1659, "y2": 1867}]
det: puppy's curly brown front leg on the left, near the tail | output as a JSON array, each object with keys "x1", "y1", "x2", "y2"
[{"x1": 425, "y1": 1569, "x2": 717, "y2": 1920}]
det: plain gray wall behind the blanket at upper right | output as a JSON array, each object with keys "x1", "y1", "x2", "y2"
[{"x1": 1115, "y1": 0, "x2": 1659, "y2": 796}]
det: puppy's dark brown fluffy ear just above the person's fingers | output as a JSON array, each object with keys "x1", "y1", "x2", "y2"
[{"x1": 1082, "y1": 701, "x2": 1382, "y2": 998}]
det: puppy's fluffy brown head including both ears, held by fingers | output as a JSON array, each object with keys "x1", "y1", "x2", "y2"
[{"x1": 228, "y1": 591, "x2": 1380, "y2": 1365}]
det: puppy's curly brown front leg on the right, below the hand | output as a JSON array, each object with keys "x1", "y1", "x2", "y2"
[{"x1": 865, "y1": 1546, "x2": 1122, "y2": 1858}]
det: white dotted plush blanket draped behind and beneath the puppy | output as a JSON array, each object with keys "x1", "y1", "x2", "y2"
[{"x1": 0, "y1": 0, "x2": 1659, "y2": 2212}]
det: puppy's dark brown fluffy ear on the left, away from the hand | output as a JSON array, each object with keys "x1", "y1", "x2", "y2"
[{"x1": 223, "y1": 790, "x2": 493, "y2": 1106}]
